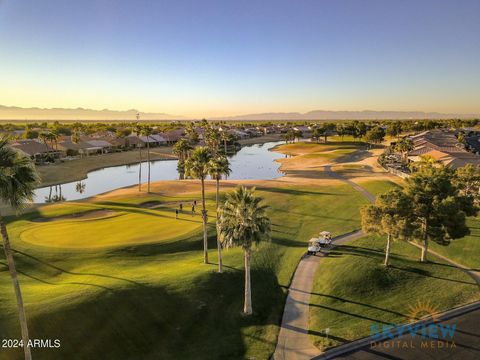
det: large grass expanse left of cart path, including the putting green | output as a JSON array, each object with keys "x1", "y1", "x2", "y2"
[{"x1": 0, "y1": 185, "x2": 372, "y2": 360}]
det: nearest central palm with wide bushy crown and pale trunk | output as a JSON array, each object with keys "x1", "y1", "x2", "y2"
[{"x1": 220, "y1": 186, "x2": 270, "y2": 315}]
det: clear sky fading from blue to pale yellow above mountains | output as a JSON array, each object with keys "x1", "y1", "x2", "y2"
[{"x1": 0, "y1": 0, "x2": 480, "y2": 117}]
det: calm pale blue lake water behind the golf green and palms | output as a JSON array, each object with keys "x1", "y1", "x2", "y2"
[{"x1": 34, "y1": 141, "x2": 285, "y2": 203}]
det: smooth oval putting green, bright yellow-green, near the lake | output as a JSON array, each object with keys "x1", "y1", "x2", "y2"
[{"x1": 20, "y1": 209, "x2": 202, "y2": 249}]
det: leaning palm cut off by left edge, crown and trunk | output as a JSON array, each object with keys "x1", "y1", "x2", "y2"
[{"x1": 0, "y1": 138, "x2": 39, "y2": 360}]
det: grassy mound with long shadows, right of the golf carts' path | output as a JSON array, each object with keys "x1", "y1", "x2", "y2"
[{"x1": 310, "y1": 237, "x2": 480, "y2": 349}]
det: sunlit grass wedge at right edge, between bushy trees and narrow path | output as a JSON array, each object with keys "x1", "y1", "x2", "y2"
[{"x1": 429, "y1": 218, "x2": 480, "y2": 271}]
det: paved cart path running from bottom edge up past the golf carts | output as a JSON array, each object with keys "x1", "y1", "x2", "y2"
[{"x1": 273, "y1": 230, "x2": 364, "y2": 360}]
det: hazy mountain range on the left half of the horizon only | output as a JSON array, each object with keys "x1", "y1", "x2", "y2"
[{"x1": 0, "y1": 105, "x2": 184, "y2": 121}]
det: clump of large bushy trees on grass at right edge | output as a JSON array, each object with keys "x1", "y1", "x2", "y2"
[{"x1": 361, "y1": 162, "x2": 480, "y2": 266}]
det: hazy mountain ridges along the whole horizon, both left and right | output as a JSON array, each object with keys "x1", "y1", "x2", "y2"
[{"x1": 0, "y1": 105, "x2": 480, "y2": 121}]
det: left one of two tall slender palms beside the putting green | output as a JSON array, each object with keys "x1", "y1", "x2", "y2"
[{"x1": 185, "y1": 146, "x2": 212, "y2": 264}]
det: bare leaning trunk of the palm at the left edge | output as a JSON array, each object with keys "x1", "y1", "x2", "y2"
[{"x1": 0, "y1": 214, "x2": 32, "y2": 360}]
